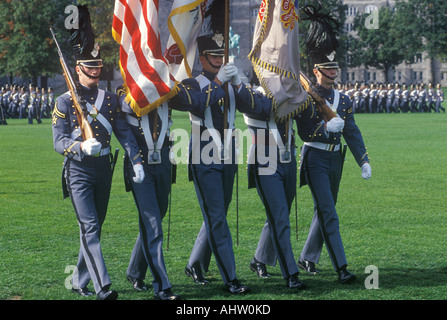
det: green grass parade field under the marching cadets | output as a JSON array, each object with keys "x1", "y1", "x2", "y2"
[{"x1": 0, "y1": 113, "x2": 447, "y2": 300}]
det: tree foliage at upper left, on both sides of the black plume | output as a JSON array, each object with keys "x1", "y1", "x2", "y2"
[{"x1": 0, "y1": 0, "x2": 119, "y2": 87}]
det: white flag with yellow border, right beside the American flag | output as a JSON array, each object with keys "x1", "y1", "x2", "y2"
[{"x1": 165, "y1": 0, "x2": 212, "y2": 81}]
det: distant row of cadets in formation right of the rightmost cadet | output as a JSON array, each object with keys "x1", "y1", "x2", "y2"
[{"x1": 338, "y1": 83, "x2": 445, "y2": 113}]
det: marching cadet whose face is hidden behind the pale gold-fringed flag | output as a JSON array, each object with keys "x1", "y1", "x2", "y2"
[{"x1": 237, "y1": 77, "x2": 343, "y2": 290}]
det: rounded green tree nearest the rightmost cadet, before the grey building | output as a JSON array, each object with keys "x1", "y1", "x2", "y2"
[{"x1": 349, "y1": 7, "x2": 406, "y2": 82}]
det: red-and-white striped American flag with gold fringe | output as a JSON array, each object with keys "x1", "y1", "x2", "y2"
[{"x1": 112, "y1": 0, "x2": 177, "y2": 116}]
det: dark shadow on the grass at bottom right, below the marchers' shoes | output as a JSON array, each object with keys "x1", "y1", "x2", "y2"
[{"x1": 161, "y1": 266, "x2": 447, "y2": 301}]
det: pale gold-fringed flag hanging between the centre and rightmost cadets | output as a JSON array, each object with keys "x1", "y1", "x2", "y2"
[{"x1": 248, "y1": 0, "x2": 308, "y2": 121}]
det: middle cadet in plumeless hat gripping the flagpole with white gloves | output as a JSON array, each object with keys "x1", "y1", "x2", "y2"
[{"x1": 169, "y1": 31, "x2": 272, "y2": 294}]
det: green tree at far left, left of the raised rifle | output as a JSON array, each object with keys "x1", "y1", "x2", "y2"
[{"x1": 0, "y1": 0, "x2": 70, "y2": 83}]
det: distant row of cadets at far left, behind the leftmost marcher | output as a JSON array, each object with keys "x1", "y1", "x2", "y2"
[{"x1": 0, "y1": 84, "x2": 55, "y2": 124}]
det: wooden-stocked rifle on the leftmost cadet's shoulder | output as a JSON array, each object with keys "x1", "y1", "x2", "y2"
[{"x1": 50, "y1": 27, "x2": 98, "y2": 141}]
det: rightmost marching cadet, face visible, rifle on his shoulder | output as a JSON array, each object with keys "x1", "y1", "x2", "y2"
[{"x1": 298, "y1": 48, "x2": 371, "y2": 283}]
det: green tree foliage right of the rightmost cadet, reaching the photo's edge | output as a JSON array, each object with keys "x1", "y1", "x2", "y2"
[{"x1": 349, "y1": 0, "x2": 447, "y2": 81}]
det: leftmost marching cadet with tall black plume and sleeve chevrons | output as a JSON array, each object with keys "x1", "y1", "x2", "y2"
[{"x1": 52, "y1": 6, "x2": 144, "y2": 300}]
